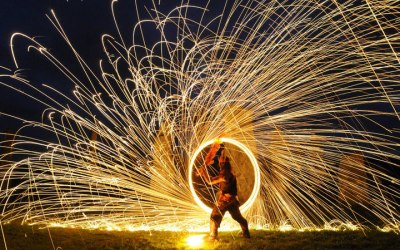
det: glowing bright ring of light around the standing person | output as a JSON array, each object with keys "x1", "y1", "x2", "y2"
[{"x1": 189, "y1": 137, "x2": 261, "y2": 213}]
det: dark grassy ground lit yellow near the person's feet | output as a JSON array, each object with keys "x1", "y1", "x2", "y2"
[{"x1": 0, "y1": 225, "x2": 400, "y2": 250}]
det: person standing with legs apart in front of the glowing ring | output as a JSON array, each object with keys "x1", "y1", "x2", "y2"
[{"x1": 198, "y1": 140, "x2": 250, "y2": 241}]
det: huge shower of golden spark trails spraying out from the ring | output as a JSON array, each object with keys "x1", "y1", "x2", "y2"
[{"x1": 0, "y1": 0, "x2": 400, "y2": 231}]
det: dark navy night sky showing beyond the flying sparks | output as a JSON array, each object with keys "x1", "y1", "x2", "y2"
[{"x1": 0, "y1": 0, "x2": 398, "y2": 145}]
